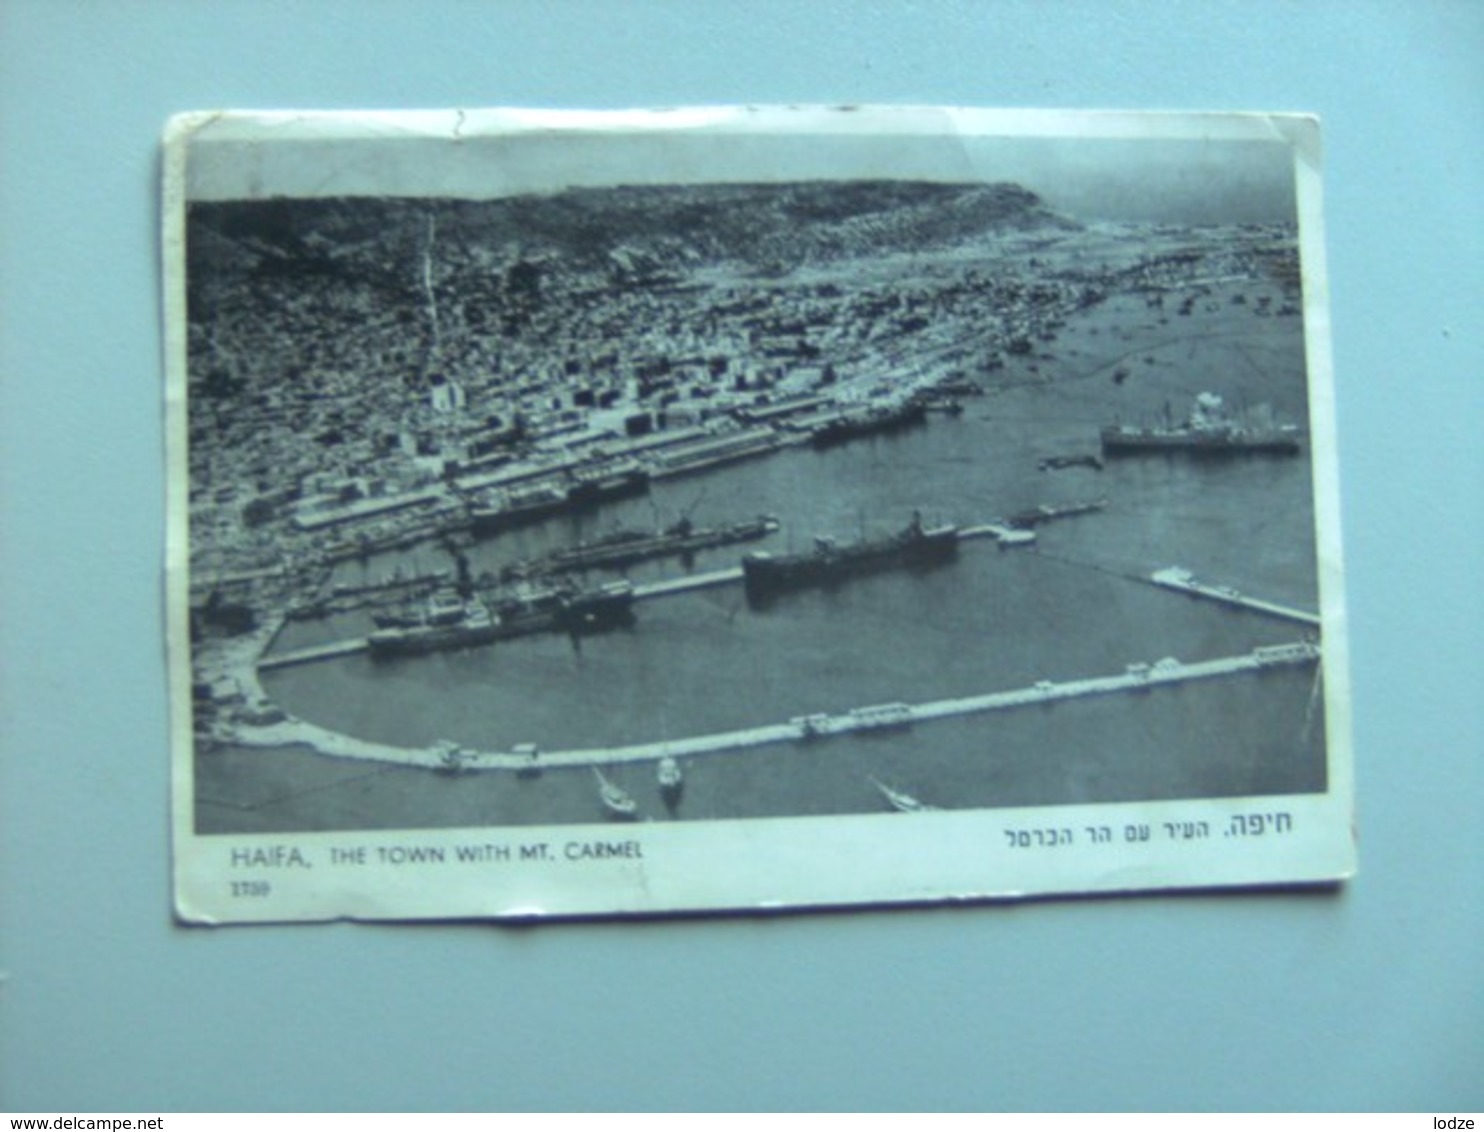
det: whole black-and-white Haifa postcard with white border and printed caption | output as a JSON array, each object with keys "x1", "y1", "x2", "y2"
[{"x1": 163, "y1": 107, "x2": 1355, "y2": 923}]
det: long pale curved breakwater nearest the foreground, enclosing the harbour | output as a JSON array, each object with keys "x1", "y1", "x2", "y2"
[{"x1": 214, "y1": 639, "x2": 1321, "y2": 771}]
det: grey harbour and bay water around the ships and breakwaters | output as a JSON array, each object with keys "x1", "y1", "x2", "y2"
[{"x1": 197, "y1": 285, "x2": 1327, "y2": 832}]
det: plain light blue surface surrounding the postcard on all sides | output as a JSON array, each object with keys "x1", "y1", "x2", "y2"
[{"x1": 0, "y1": 0, "x2": 1484, "y2": 1113}]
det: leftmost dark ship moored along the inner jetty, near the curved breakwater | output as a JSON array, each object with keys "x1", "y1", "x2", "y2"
[{"x1": 367, "y1": 582, "x2": 634, "y2": 657}]
